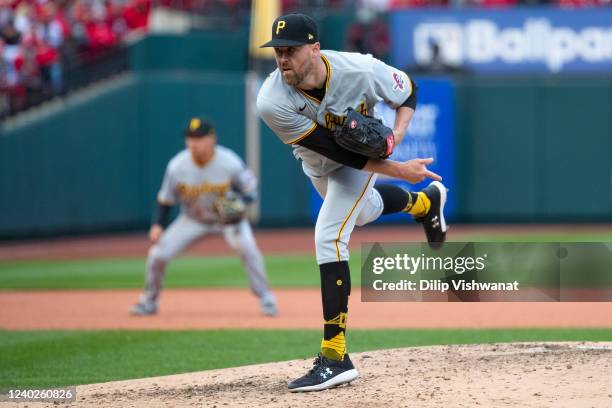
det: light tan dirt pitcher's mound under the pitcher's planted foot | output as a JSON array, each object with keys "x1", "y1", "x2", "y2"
[{"x1": 62, "y1": 343, "x2": 612, "y2": 408}]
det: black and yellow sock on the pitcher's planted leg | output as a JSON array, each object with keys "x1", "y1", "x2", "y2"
[{"x1": 319, "y1": 261, "x2": 351, "y2": 361}]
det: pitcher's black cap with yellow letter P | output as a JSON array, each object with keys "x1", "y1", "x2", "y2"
[{"x1": 259, "y1": 14, "x2": 319, "y2": 48}]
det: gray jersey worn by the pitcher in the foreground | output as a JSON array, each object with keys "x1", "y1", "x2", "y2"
[{"x1": 257, "y1": 50, "x2": 412, "y2": 175}]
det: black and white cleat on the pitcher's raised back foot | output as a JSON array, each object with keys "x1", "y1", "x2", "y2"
[{"x1": 415, "y1": 181, "x2": 448, "y2": 249}]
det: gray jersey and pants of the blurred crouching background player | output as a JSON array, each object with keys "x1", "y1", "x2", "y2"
[{"x1": 140, "y1": 145, "x2": 273, "y2": 303}]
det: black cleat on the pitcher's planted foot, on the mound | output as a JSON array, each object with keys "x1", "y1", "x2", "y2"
[{"x1": 289, "y1": 354, "x2": 359, "y2": 392}]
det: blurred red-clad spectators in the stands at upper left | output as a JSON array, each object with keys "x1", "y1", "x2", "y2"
[{"x1": 0, "y1": 0, "x2": 151, "y2": 116}]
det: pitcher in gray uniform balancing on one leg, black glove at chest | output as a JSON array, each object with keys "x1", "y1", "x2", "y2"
[{"x1": 257, "y1": 14, "x2": 447, "y2": 391}]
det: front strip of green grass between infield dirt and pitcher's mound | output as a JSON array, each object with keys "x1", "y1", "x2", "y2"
[{"x1": 0, "y1": 329, "x2": 612, "y2": 388}]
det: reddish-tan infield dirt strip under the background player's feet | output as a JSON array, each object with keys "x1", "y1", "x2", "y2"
[{"x1": 0, "y1": 289, "x2": 612, "y2": 330}]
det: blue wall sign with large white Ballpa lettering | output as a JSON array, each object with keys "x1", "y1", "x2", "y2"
[{"x1": 390, "y1": 7, "x2": 612, "y2": 73}]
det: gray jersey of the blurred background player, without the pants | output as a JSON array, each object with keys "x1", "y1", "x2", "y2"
[{"x1": 157, "y1": 145, "x2": 257, "y2": 224}]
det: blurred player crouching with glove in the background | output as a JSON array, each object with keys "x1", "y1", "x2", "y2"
[{"x1": 131, "y1": 118, "x2": 277, "y2": 316}]
